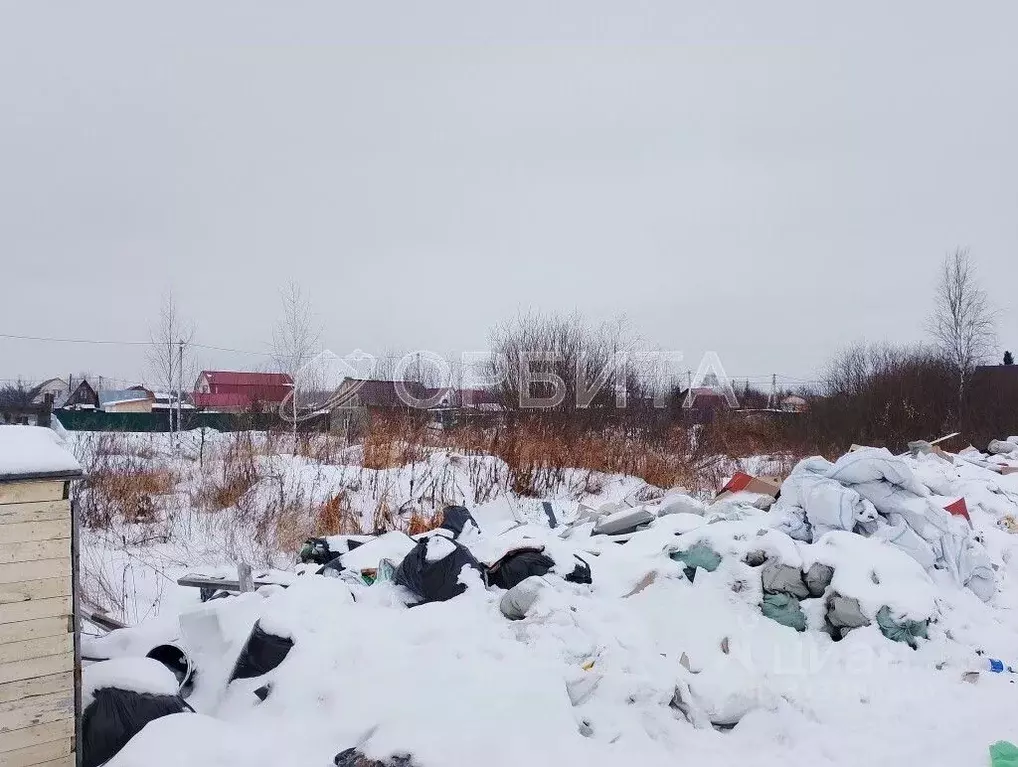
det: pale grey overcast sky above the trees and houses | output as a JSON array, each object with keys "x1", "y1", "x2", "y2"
[{"x1": 0, "y1": 0, "x2": 1018, "y2": 389}]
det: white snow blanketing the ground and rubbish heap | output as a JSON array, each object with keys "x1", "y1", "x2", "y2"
[{"x1": 61, "y1": 431, "x2": 1018, "y2": 767}]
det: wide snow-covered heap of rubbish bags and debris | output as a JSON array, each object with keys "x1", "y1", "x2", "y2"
[{"x1": 77, "y1": 451, "x2": 1018, "y2": 767}]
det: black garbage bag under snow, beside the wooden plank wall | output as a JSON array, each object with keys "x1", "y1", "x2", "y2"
[{"x1": 81, "y1": 688, "x2": 193, "y2": 767}]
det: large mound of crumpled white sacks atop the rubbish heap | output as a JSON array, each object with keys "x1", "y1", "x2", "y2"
[{"x1": 772, "y1": 447, "x2": 997, "y2": 600}]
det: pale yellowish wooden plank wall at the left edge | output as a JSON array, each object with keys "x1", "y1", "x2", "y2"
[{"x1": 0, "y1": 480, "x2": 75, "y2": 767}]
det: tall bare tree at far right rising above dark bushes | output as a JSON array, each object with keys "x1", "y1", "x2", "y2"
[{"x1": 927, "y1": 248, "x2": 997, "y2": 425}]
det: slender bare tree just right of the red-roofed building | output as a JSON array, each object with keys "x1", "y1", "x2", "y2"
[{"x1": 272, "y1": 280, "x2": 322, "y2": 448}]
